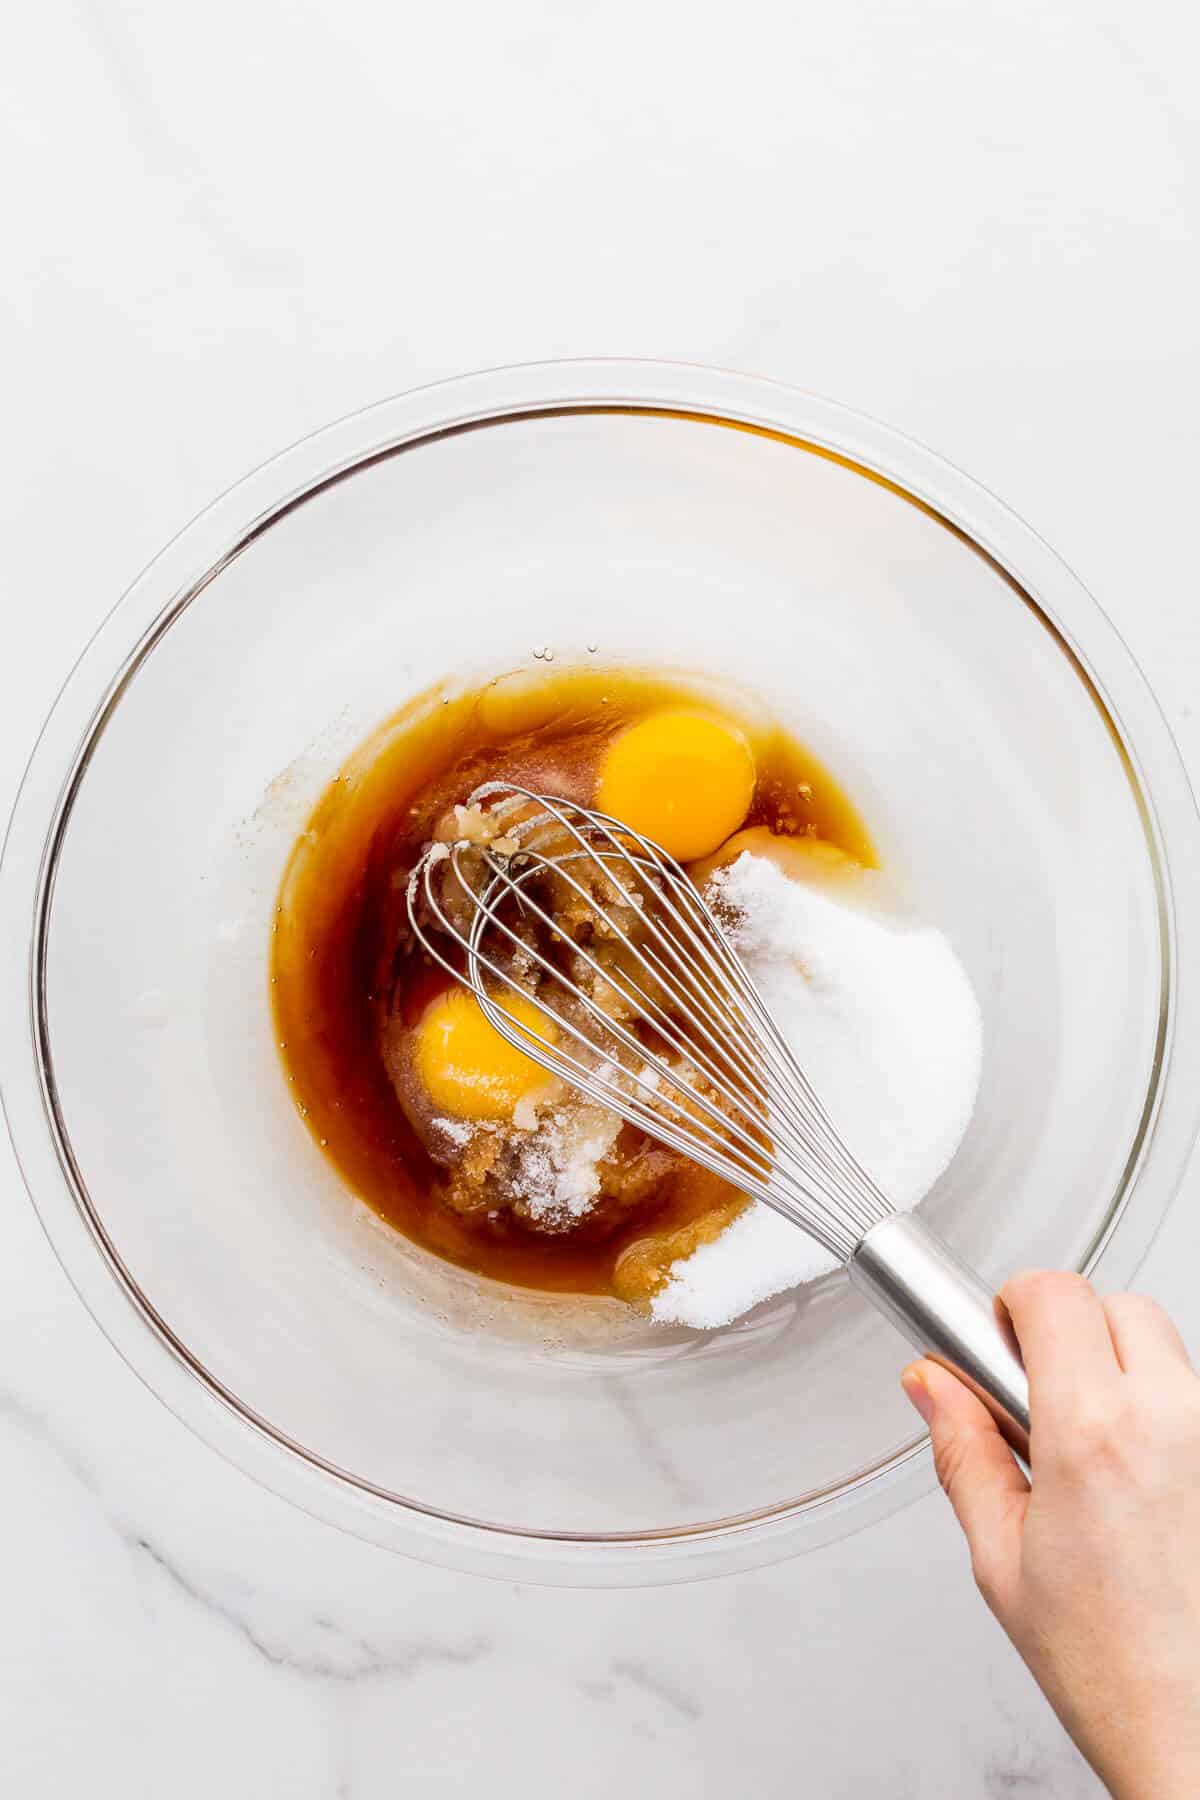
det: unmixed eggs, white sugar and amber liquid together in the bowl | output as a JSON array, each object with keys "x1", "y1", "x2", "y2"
[{"x1": 272, "y1": 670, "x2": 981, "y2": 1327}]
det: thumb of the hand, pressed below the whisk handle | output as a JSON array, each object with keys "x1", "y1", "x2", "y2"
[{"x1": 901, "y1": 1357, "x2": 1029, "y2": 1611}]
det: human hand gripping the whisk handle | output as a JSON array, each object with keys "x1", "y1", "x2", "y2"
[{"x1": 903, "y1": 1273, "x2": 1200, "y2": 1800}]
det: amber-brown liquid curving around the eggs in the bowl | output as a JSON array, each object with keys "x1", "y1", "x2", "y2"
[{"x1": 270, "y1": 670, "x2": 874, "y2": 1300}]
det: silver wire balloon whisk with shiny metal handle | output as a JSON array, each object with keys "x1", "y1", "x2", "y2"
[{"x1": 407, "y1": 783, "x2": 1029, "y2": 1454}]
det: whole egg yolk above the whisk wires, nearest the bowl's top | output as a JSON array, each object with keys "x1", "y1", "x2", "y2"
[{"x1": 596, "y1": 713, "x2": 756, "y2": 862}]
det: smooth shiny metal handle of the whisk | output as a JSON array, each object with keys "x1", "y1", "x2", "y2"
[{"x1": 849, "y1": 1213, "x2": 1029, "y2": 1462}]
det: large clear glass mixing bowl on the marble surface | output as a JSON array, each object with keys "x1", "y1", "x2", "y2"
[{"x1": 0, "y1": 362, "x2": 1200, "y2": 1582}]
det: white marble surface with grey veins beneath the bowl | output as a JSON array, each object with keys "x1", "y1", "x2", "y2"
[{"x1": 0, "y1": 0, "x2": 1200, "y2": 1800}]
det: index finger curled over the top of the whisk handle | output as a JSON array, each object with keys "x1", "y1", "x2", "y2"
[{"x1": 1000, "y1": 1269, "x2": 1121, "y2": 1435}]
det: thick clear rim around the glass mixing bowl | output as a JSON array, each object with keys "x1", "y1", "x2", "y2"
[{"x1": 0, "y1": 360, "x2": 1200, "y2": 1586}]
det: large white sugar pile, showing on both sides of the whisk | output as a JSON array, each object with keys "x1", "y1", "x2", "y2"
[{"x1": 651, "y1": 851, "x2": 982, "y2": 1327}]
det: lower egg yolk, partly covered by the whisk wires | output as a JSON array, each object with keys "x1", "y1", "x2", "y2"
[{"x1": 416, "y1": 988, "x2": 558, "y2": 1120}]
